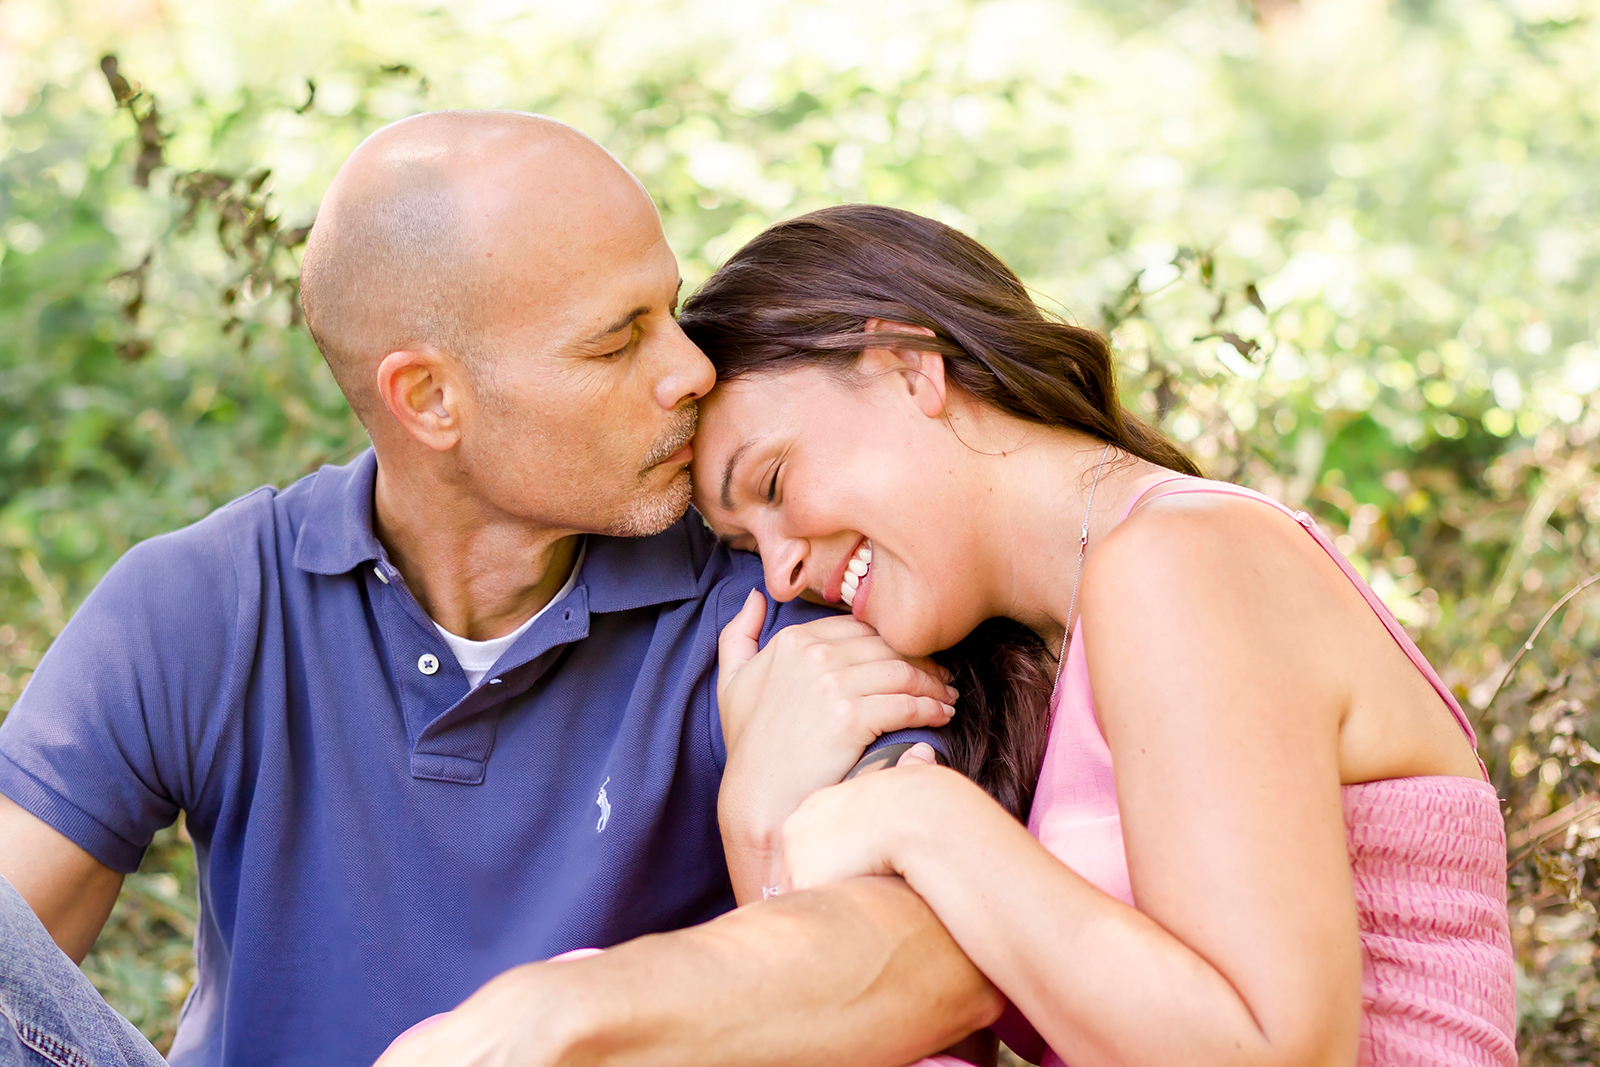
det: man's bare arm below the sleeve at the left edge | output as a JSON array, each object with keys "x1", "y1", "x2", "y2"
[{"x1": 0, "y1": 795, "x2": 123, "y2": 963}]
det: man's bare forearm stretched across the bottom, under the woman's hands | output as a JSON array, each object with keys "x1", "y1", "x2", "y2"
[{"x1": 379, "y1": 878, "x2": 1003, "y2": 1067}]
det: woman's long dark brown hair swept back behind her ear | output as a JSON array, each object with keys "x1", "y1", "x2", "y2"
[{"x1": 678, "y1": 205, "x2": 1200, "y2": 821}]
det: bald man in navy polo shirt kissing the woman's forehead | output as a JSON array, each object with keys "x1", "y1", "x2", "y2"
[{"x1": 0, "y1": 112, "x2": 994, "y2": 1065}]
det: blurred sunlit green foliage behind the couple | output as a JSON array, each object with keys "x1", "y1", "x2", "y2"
[{"x1": 0, "y1": 0, "x2": 1600, "y2": 1064}]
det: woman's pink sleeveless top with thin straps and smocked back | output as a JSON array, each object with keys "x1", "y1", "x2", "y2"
[{"x1": 1006, "y1": 475, "x2": 1517, "y2": 1067}]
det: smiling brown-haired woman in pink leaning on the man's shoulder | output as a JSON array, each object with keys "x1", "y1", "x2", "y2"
[{"x1": 680, "y1": 205, "x2": 1515, "y2": 1067}]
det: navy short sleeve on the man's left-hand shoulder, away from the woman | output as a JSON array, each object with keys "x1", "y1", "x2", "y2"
[{"x1": 0, "y1": 498, "x2": 259, "y2": 873}]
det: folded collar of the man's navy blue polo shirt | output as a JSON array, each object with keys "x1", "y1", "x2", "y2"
[{"x1": 294, "y1": 448, "x2": 699, "y2": 613}]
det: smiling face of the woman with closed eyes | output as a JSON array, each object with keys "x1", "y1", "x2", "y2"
[{"x1": 691, "y1": 361, "x2": 995, "y2": 654}]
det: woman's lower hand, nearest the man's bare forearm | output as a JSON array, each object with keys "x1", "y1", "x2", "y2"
[{"x1": 782, "y1": 744, "x2": 992, "y2": 889}]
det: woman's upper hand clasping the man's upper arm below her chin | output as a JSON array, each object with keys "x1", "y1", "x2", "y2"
[{"x1": 717, "y1": 590, "x2": 955, "y2": 904}]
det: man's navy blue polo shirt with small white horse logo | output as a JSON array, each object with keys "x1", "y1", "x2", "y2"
[{"x1": 0, "y1": 453, "x2": 821, "y2": 1067}]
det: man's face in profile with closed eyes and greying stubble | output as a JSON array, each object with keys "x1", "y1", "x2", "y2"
[{"x1": 458, "y1": 181, "x2": 715, "y2": 536}]
